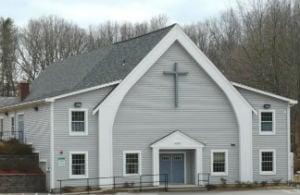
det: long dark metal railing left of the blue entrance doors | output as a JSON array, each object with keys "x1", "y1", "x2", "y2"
[{"x1": 57, "y1": 174, "x2": 168, "y2": 194}]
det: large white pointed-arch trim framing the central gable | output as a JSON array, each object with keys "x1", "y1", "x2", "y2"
[{"x1": 93, "y1": 25, "x2": 256, "y2": 182}]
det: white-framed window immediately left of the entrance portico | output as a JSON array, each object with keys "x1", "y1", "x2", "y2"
[{"x1": 123, "y1": 151, "x2": 141, "y2": 176}]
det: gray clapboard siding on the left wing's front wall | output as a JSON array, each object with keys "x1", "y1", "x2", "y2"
[{"x1": 54, "y1": 87, "x2": 112, "y2": 187}]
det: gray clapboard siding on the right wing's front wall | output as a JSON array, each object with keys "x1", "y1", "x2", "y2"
[{"x1": 238, "y1": 88, "x2": 288, "y2": 182}]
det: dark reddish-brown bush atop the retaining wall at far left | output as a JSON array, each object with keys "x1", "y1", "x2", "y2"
[{"x1": 0, "y1": 139, "x2": 33, "y2": 155}]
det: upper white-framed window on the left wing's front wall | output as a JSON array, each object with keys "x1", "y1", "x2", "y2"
[{"x1": 69, "y1": 109, "x2": 88, "y2": 135}]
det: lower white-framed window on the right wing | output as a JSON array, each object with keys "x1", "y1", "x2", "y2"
[{"x1": 259, "y1": 150, "x2": 276, "y2": 175}]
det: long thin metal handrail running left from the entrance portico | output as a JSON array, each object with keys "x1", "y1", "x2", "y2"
[{"x1": 57, "y1": 174, "x2": 168, "y2": 194}]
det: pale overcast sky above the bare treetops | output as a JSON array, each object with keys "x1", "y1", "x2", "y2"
[{"x1": 0, "y1": 0, "x2": 236, "y2": 27}]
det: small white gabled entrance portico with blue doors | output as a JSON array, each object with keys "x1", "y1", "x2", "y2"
[{"x1": 151, "y1": 131, "x2": 204, "y2": 185}]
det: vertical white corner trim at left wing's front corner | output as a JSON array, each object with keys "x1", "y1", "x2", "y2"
[{"x1": 50, "y1": 102, "x2": 55, "y2": 189}]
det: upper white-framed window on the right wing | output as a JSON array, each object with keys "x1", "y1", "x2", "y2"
[{"x1": 259, "y1": 110, "x2": 275, "y2": 135}]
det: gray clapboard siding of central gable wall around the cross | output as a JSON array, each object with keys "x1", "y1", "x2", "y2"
[{"x1": 113, "y1": 43, "x2": 239, "y2": 183}]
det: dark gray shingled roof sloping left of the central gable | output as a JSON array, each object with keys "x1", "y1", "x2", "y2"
[{"x1": 24, "y1": 24, "x2": 175, "y2": 102}]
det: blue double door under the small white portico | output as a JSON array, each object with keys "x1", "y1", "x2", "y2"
[{"x1": 159, "y1": 153, "x2": 184, "y2": 184}]
